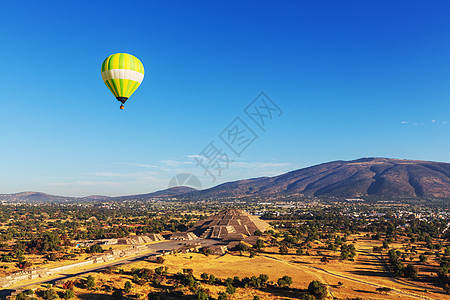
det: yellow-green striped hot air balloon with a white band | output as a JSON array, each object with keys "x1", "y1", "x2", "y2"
[{"x1": 102, "y1": 53, "x2": 144, "y2": 109}]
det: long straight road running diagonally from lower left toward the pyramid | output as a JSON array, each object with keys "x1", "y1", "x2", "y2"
[{"x1": 0, "y1": 239, "x2": 223, "y2": 299}]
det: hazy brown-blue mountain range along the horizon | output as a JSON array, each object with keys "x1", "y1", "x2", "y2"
[{"x1": 0, "y1": 158, "x2": 450, "y2": 202}]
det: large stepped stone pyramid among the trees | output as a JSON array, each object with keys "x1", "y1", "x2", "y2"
[{"x1": 188, "y1": 209, "x2": 270, "y2": 240}]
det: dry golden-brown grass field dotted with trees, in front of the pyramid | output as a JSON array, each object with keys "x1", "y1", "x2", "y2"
[{"x1": 7, "y1": 234, "x2": 450, "y2": 299}]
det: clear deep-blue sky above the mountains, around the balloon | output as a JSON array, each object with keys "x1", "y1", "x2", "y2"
[{"x1": 0, "y1": 1, "x2": 450, "y2": 196}]
